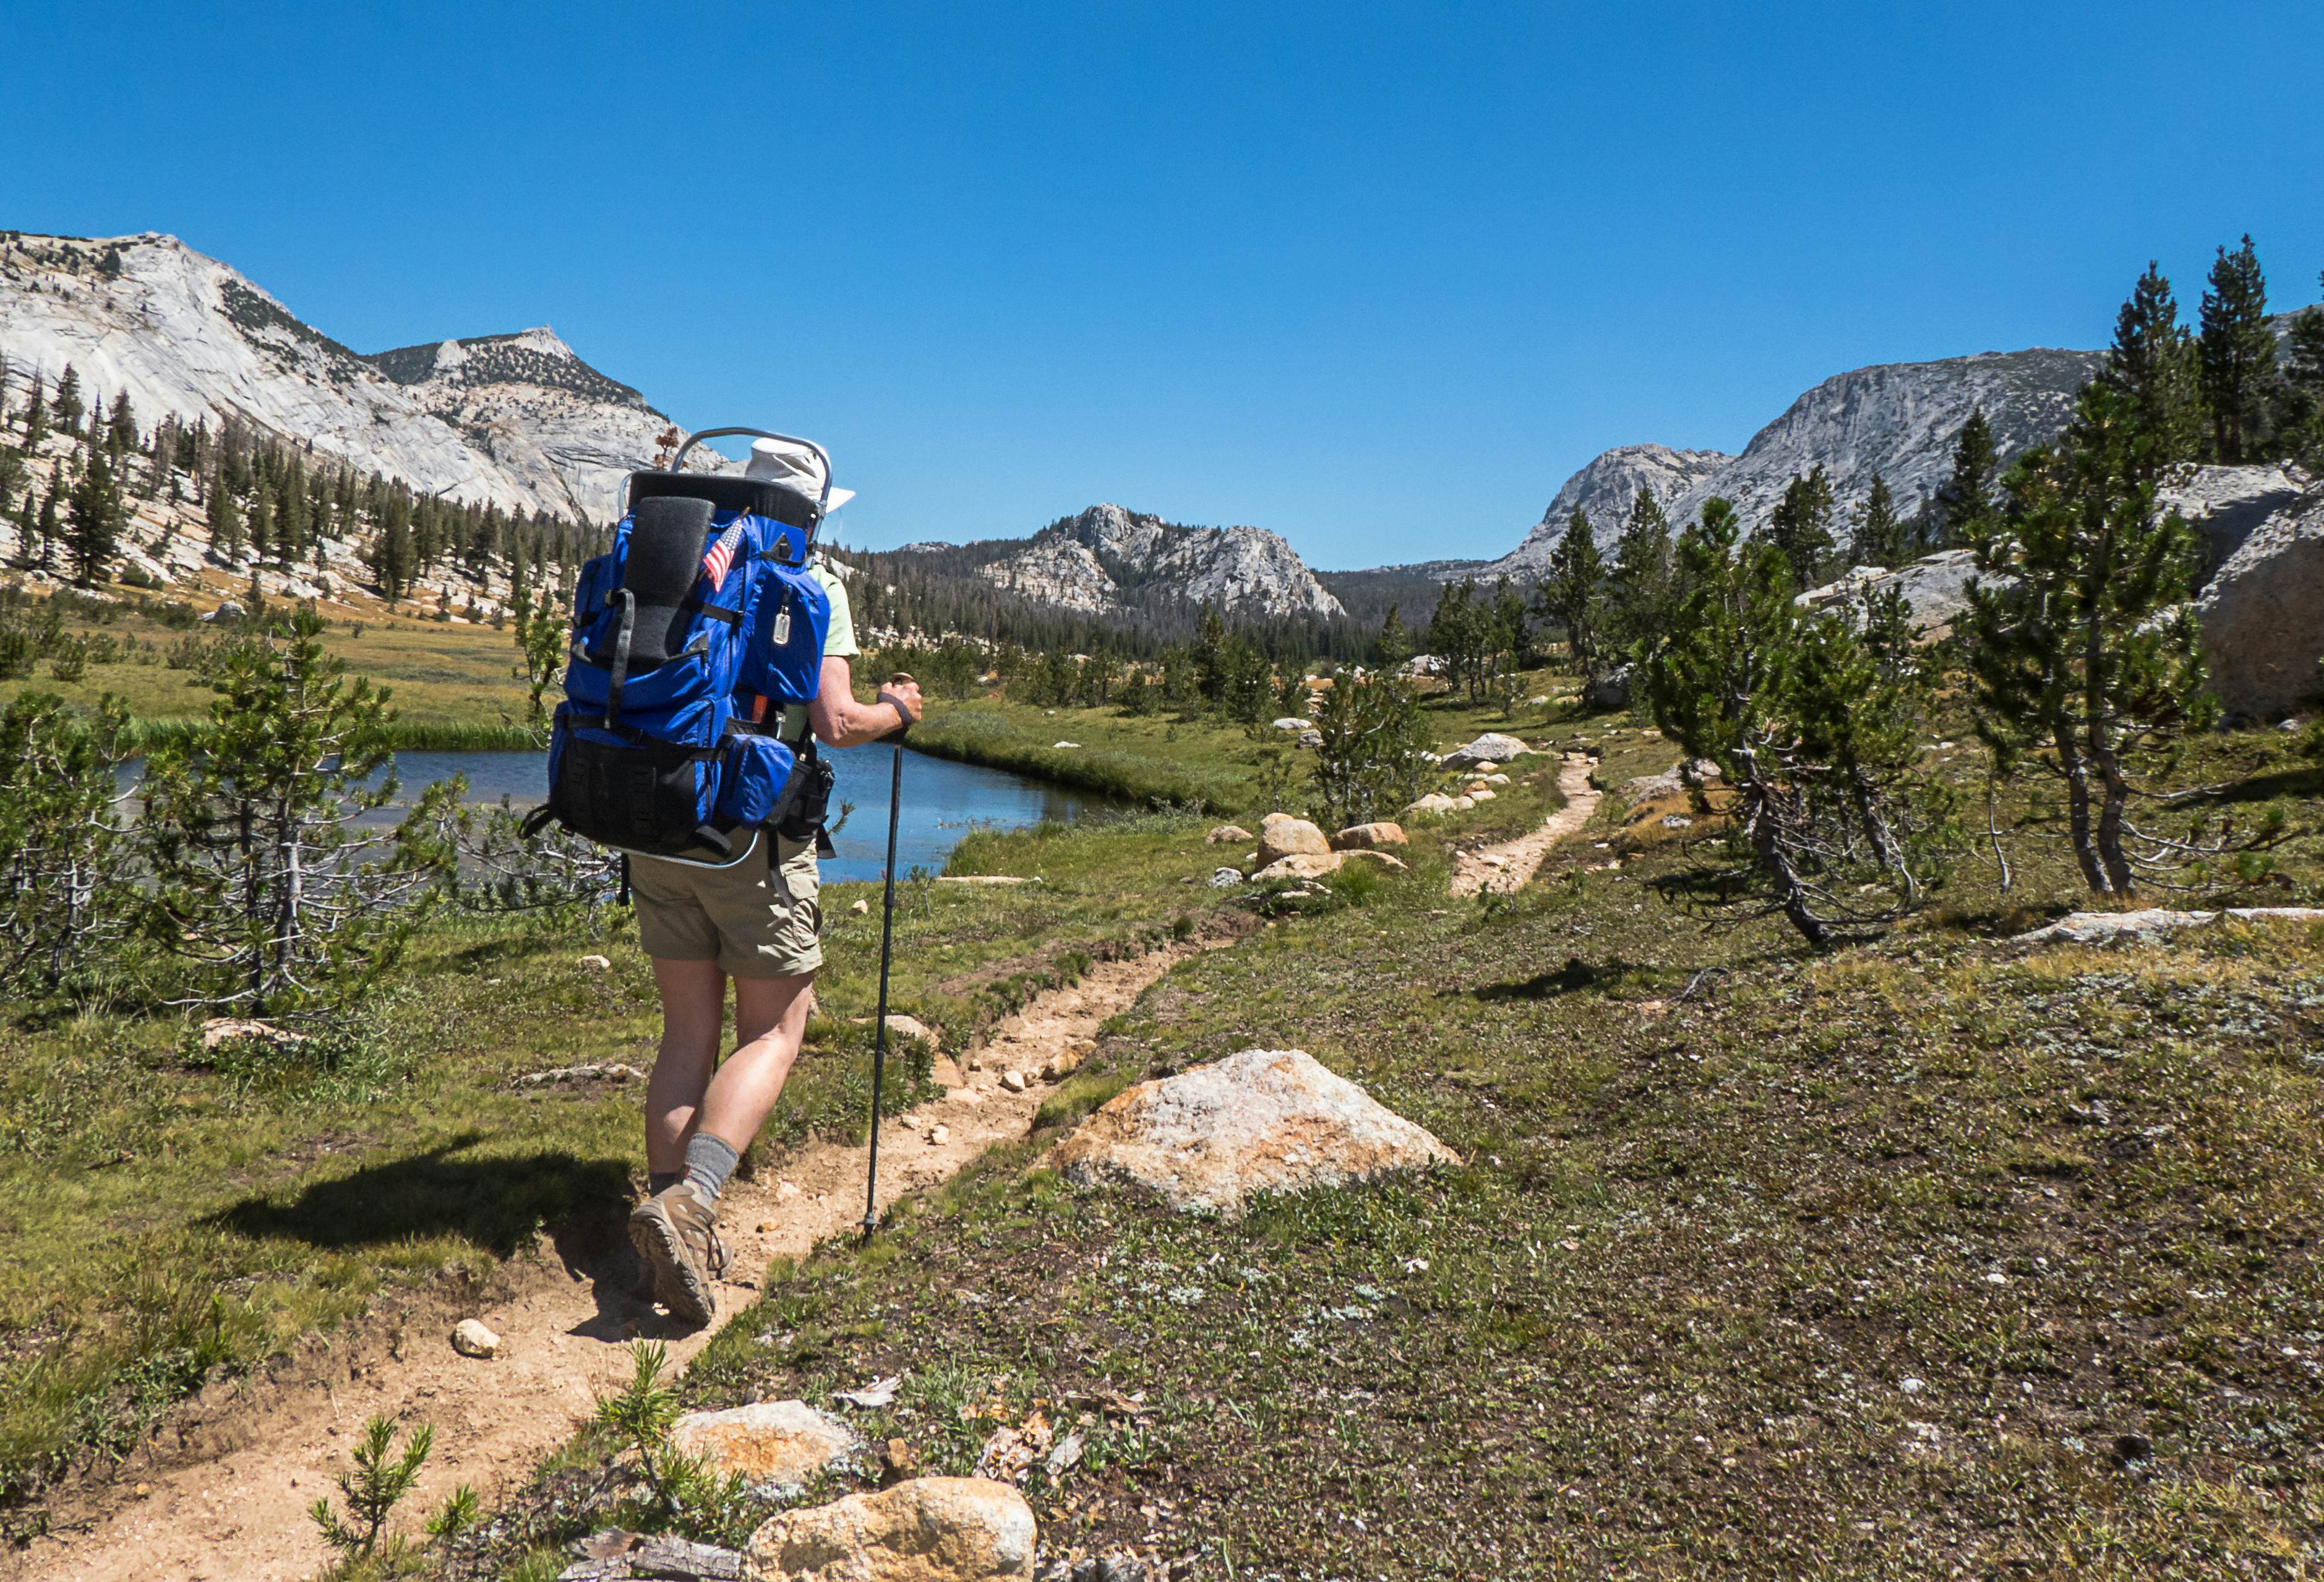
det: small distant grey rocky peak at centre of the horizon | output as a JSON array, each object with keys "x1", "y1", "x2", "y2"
[{"x1": 957, "y1": 504, "x2": 1345, "y2": 616}]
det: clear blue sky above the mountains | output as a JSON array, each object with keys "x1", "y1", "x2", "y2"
[{"x1": 0, "y1": 0, "x2": 2324, "y2": 567}]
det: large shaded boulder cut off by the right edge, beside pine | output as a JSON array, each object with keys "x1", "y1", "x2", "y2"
[{"x1": 2194, "y1": 490, "x2": 2324, "y2": 720}]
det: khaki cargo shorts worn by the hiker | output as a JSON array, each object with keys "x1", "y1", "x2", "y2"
[{"x1": 630, "y1": 829, "x2": 823, "y2": 978}]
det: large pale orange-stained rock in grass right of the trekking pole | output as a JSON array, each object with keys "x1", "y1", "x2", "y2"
[{"x1": 1055, "y1": 1050, "x2": 1455, "y2": 1219}]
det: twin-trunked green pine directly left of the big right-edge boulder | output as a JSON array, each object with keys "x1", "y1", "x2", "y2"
[{"x1": 1964, "y1": 379, "x2": 2217, "y2": 895}]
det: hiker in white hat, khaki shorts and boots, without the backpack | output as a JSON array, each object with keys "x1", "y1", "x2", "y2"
[{"x1": 630, "y1": 439, "x2": 920, "y2": 1324}]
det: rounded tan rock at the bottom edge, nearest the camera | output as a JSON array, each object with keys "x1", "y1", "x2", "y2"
[{"x1": 744, "y1": 1477, "x2": 1037, "y2": 1582}]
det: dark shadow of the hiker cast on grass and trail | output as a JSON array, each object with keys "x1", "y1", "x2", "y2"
[{"x1": 207, "y1": 1132, "x2": 665, "y2": 1341}]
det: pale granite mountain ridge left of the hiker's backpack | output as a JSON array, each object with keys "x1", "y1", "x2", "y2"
[{"x1": 0, "y1": 232, "x2": 669, "y2": 523}]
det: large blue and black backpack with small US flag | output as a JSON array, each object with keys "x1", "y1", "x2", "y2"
[{"x1": 530, "y1": 471, "x2": 832, "y2": 864}]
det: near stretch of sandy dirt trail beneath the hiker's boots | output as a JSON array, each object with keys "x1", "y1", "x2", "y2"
[{"x1": 22, "y1": 941, "x2": 1222, "y2": 1582}]
